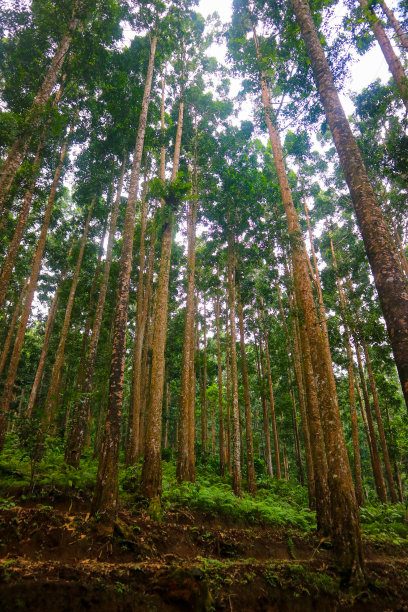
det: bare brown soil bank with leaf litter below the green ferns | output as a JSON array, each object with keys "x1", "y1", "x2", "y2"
[{"x1": 0, "y1": 501, "x2": 408, "y2": 612}]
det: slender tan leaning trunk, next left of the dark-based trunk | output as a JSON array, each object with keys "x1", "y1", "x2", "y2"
[{"x1": 43, "y1": 197, "x2": 96, "y2": 431}]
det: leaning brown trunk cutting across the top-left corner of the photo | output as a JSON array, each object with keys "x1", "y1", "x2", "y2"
[{"x1": 0, "y1": 0, "x2": 82, "y2": 210}]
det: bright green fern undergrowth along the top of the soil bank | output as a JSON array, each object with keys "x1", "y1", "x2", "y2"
[{"x1": 0, "y1": 436, "x2": 408, "y2": 546}]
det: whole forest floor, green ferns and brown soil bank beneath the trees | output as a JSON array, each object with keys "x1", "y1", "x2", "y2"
[{"x1": 0, "y1": 438, "x2": 408, "y2": 612}]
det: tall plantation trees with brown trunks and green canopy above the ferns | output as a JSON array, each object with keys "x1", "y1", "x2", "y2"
[{"x1": 0, "y1": 0, "x2": 408, "y2": 582}]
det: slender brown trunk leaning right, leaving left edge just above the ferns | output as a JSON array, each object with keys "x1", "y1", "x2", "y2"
[{"x1": 0, "y1": 118, "x2": 73, "y2": 451}]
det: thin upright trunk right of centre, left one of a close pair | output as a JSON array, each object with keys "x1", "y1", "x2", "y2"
[{"x1": 228, "y1": 232, "x2": 242, "y2": 497}]
